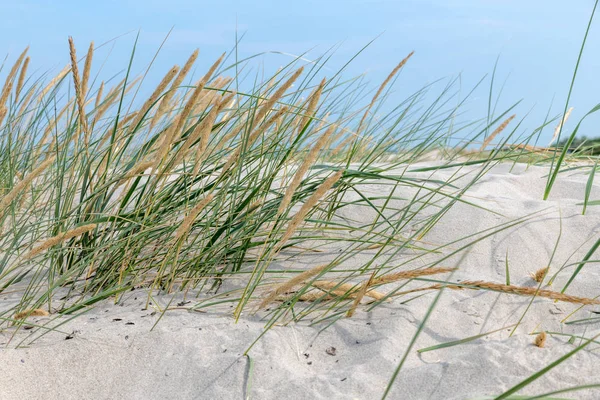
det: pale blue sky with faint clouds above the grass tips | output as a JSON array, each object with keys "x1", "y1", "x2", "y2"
[{"x1": 0, "y1": 0, "x2": 600, "y2": 144}]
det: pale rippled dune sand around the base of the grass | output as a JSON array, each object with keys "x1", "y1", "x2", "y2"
[{"x1": 0, "y1": 164, "x2": 600, "y2": 399}]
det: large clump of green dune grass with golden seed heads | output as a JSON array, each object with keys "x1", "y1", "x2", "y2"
[{"x1": 0, "y1": 38, "x2": 596, "y2": 356}]
